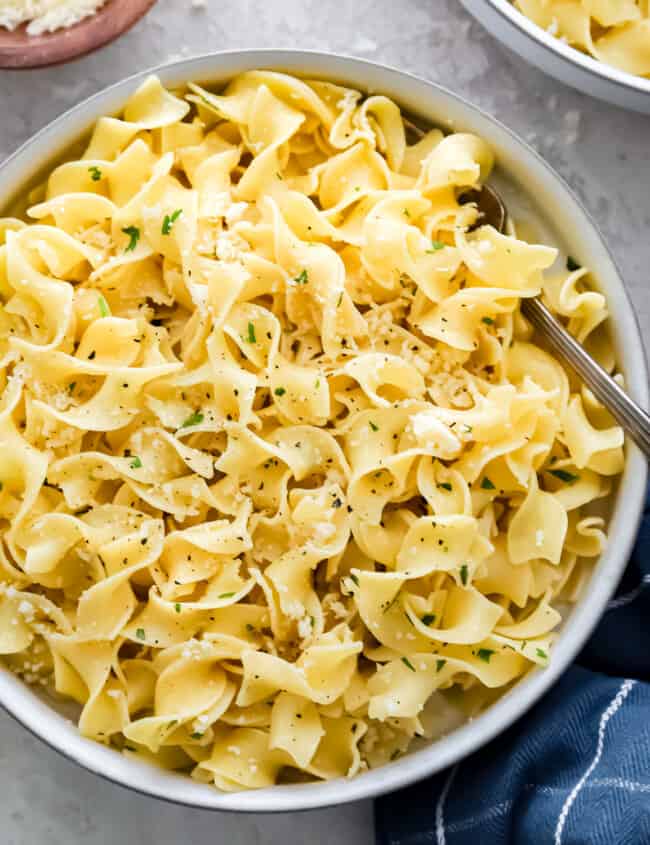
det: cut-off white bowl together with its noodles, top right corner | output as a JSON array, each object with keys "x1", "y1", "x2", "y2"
[{"x1": 461, "y1": 0, "x2": 650, "y2": 113}]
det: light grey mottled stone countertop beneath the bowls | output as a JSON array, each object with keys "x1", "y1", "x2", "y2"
[{"x1": 0, "y1": 0, "x2": 650, "y2": 845}]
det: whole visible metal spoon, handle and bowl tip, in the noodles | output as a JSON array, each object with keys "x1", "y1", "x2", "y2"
[{"x1": 460, "y1": 185, "x2": 650, "y2": 459}]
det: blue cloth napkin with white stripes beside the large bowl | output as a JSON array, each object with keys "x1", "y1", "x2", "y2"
[{"x1": 375, "y1": 494, "x2": 650, "y2": 845}]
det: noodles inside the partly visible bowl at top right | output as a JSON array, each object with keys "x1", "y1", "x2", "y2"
[{"x1": 513, "y1": 0, "x2": 650, "y2": 77}]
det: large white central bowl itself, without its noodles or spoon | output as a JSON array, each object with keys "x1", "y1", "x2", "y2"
[{"x1": 0, "y1": 50, "x2": 648, "y2": 811}]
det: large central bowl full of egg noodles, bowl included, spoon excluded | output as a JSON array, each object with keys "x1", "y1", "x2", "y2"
[{"x1": 0, "y1": 51, "x2": 645, "y2": 809}]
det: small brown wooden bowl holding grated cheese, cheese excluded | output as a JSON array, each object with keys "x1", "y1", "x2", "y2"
[{"x1": 0, "y1": 0, "x2": 156, "y2": 69}]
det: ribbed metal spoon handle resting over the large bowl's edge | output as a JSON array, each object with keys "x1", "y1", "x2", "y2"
[{"x1": 521, "y1": 297, "x2": 650, "y2": 459}]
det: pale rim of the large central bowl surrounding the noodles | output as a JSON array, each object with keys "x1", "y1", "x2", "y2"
[{"x1": 0, "y1": 48, "x2": 648, "y2": 812}]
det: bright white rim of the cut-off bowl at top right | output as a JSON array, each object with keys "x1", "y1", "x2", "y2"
[{"x1": 476, "y1": 0, "x2": 650, "y2": 98}]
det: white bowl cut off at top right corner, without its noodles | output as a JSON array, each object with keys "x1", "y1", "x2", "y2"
[{"x1": 461, "y1": 0, "x2": 650, "y2": 114}]
